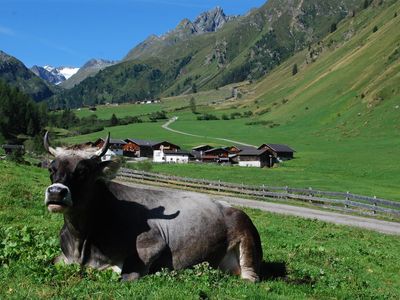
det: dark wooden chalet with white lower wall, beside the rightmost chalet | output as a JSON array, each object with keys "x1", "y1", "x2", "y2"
[{"x1": 238, "y1": 148, "x2": 274, "y2": 168}]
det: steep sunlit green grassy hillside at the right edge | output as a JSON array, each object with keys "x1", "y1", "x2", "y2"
[{"x1": 241, "y1": 1, "x2": 400, "y2": 136}]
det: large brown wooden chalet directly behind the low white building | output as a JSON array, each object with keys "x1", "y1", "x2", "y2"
[{"x1": 123, "y1": 139, "x2": 180, "y2": 158}]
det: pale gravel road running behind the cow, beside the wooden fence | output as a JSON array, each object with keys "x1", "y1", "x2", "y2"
[{"x1": 118, "y1": 181, "x2": 400, "y2": 235}]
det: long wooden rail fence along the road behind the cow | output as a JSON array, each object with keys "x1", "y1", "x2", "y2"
[{"x1": 118, "y1": 169, "x2": 400, "y2": 217}]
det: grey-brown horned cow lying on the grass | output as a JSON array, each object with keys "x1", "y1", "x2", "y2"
[{"x1": 44, "y1": 132, "x2": 262, "y2": 282}]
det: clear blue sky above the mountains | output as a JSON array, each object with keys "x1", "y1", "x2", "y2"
[{"x1": 0, "y1": 0, "x2": 266, "y2": 67}]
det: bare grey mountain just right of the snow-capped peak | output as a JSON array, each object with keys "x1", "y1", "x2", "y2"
[{"x1": 60, "y1": 59, "x2": 116, "y2": 89}]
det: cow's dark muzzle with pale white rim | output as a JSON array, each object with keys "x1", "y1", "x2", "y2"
[{"x1": 44, "y1": 183, "x2": 72, "y2": 213}]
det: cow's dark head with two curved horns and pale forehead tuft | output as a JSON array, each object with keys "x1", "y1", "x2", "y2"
[{"x1": 44, "y1": 132, "x2": 110, "y2": 213}]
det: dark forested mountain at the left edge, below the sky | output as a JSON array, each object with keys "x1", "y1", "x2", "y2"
[{"x1": 0, "y1": 51, "x2": 54, "y2": 101}]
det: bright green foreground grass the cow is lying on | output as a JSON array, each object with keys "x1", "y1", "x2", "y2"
[{"x1": 0, "y1": 161, "x2": 400, "y2": 299}]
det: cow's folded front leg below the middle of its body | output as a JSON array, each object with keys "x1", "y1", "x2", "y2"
[{"x1": 122, "y1": 229, "x2": 167, "y2": 280}]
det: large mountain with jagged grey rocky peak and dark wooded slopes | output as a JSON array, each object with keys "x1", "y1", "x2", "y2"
[{"x1": 52, "y1": 0, "x2": 364, "y2": 107}]
